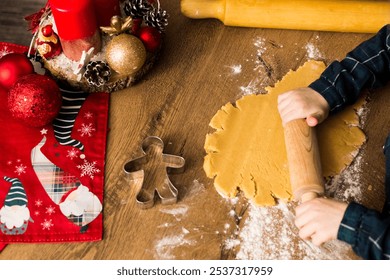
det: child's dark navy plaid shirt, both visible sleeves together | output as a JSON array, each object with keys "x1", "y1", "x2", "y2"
[{"x1": 310, "y1": 25, "x2": 390, "y2": 259}]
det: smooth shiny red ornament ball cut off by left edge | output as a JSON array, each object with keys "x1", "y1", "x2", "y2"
[{"x1": 0, "y1": 53, "x2": 34, "y2": 89}]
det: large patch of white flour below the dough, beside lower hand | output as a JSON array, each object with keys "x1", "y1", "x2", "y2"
[{"x1": 233, "y1": 203, "x2": 349, "y2": 260}]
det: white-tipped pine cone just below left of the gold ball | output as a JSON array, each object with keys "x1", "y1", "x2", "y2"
[{"x1": 84, "y1": 61, "x2": 111, "y2": 87}]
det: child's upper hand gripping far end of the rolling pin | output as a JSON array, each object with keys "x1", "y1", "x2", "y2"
[{"x1": 278, "y1": 87, "x2": 329, "y2": 126}]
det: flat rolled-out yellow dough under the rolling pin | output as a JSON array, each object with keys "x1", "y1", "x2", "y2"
[{"x1": 203, "y1": 61, "x2": 365, "y2": 206}]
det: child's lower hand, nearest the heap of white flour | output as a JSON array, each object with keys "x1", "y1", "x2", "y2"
[{"x1": 295, "y1": 198, "x2": 348, "y2": 246}]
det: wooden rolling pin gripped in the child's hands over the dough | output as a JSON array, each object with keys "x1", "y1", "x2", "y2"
[{"x1": 284, "y1": 119, "x2": 324, "y2": 202}]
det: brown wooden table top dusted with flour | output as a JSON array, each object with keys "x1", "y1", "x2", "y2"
[{"x1": 0, "y1": 0, "x2": 390, "y2": 259}]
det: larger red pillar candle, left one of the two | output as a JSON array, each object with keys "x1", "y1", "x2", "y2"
[{"x1": 49, "y1": 0, "x2": 101, "y2": 61}]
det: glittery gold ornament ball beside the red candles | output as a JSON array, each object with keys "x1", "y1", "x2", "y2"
[{"x1": 105, "y1": 34, "x2": 146, "y2": 75}]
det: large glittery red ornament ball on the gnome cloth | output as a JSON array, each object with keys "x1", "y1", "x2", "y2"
[{"x1": 7, "y1": 74, "x2": 62, "y2": 127}]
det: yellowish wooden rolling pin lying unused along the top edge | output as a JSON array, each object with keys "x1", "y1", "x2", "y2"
[{"x1": 181, "y1": 0, "x2": 390, "y2": 33}]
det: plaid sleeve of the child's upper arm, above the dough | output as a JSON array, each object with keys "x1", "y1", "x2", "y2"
[{"x1": 309, "y1": 25, "x2": 390, "y2": 113}]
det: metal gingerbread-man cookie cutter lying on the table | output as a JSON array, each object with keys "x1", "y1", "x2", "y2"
[{"x1": 124, "y1": 136, "x2": 185, "y2": 209}]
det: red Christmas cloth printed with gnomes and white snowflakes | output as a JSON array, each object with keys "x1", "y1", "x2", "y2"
[{"x1": 0, "y1": 43, "x2": 109, "y2": 247}]
